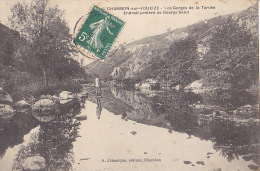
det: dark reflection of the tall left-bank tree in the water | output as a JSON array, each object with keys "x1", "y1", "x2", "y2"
[{"x1": 13, "y1": 100, "x2": 80, "y2": 170}]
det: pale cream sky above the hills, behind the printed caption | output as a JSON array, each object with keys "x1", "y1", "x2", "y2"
[{"x1": 0, "y1": 0, "x2": 257, "y2": 64}]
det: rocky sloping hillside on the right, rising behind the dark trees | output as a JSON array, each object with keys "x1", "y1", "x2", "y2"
[{"x1": 85, "y1": 4, "x2": 258, "y2": 90}]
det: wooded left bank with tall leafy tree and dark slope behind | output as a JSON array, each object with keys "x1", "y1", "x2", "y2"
[{"x1": 0, "y1": 0, "x2": 86, "y2": 99}]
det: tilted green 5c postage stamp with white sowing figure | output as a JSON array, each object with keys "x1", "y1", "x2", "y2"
[{"x1": 73, "y1": 6, "x2": 125, "y2": 59}]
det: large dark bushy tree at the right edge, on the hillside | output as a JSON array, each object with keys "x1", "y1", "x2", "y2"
[{"x1": 203, "y1": 18, "x2": 258, "y2": 90}]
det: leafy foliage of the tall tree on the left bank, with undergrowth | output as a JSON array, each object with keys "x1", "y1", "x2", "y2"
[{"x1": 9, "y1": 0, "x2": 84, "y2": 85}]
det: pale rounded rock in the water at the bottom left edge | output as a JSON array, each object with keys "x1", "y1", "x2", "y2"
[{"x1": 22, "y1": 156, "x2": 46, "y2": 171}]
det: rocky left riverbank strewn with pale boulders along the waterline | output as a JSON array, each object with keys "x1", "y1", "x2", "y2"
[{"x1": 0, "y1": 87, "x2": 88, "y2": 122}]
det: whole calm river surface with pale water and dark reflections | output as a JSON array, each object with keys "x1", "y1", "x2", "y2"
[{"x1": 0, "y1": 88, "x2": 259, "y2": 171}]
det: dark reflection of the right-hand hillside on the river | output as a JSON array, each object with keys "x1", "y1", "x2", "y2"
[{"x1": 94, "y1": 87, "x2": 259, "y2": 164}]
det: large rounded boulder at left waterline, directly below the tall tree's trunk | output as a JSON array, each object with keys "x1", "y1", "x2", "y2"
[{"x1": 32, "y1": 99, "x2": 56, "y2": 115}]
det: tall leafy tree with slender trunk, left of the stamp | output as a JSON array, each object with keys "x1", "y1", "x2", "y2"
[{"x1": 9, "y1": 0, "x2": 74, "y2": 86}]
